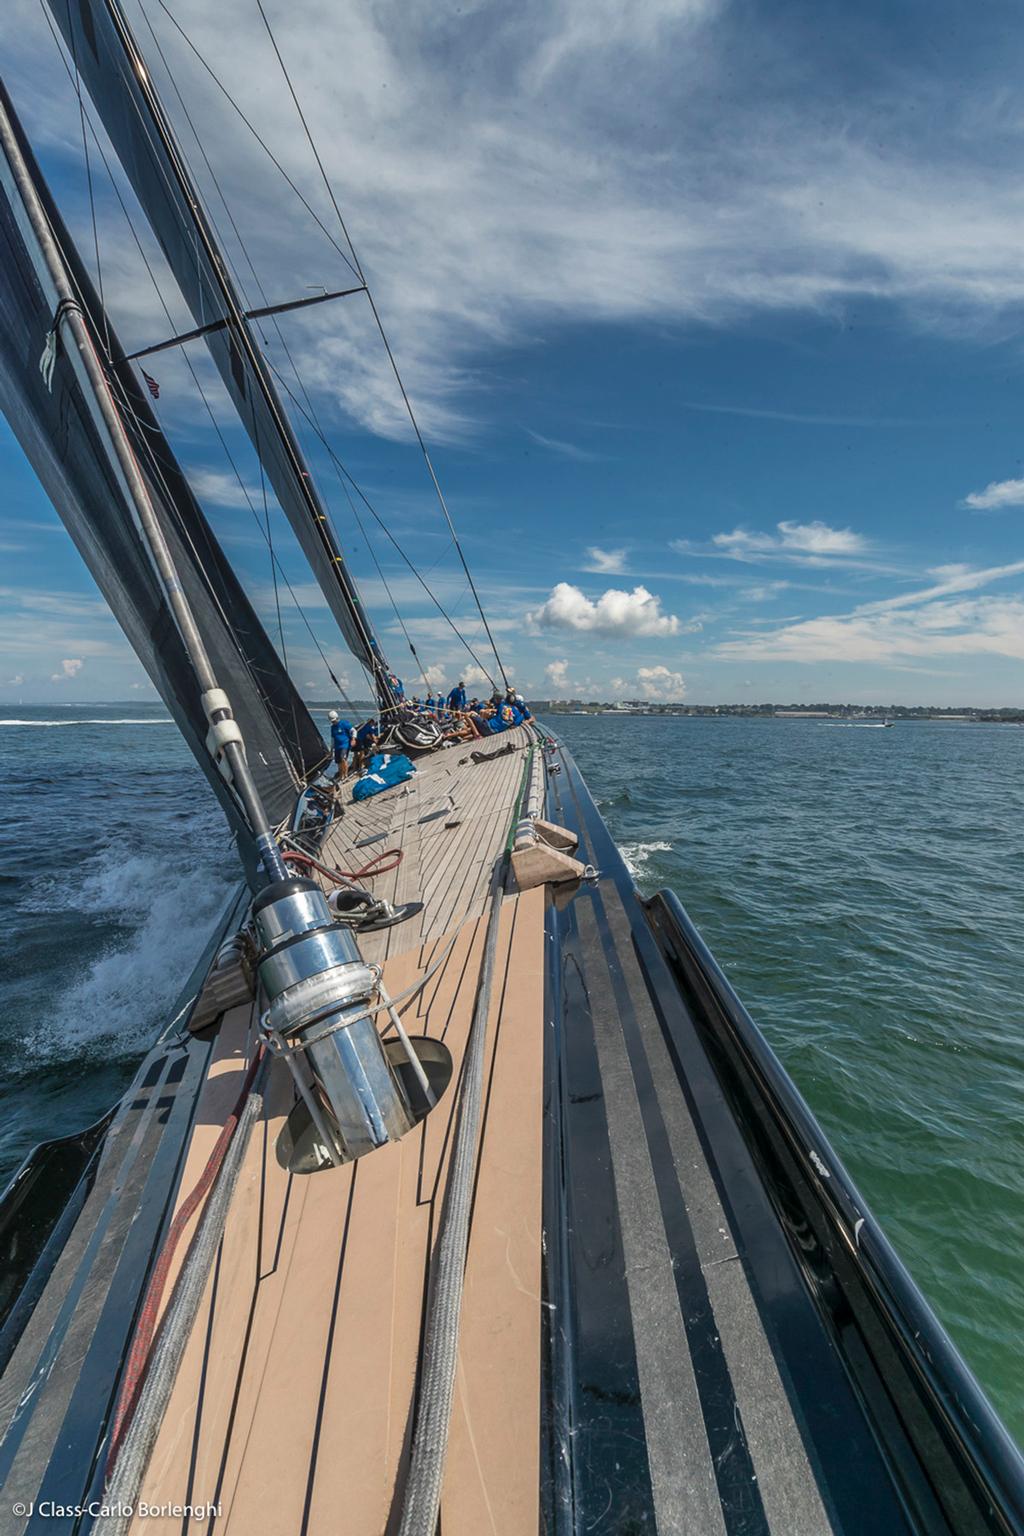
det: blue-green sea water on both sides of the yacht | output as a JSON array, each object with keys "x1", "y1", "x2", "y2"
[{"x1": 0, "y1": 705, "x2": 1024, "y2": 1442}]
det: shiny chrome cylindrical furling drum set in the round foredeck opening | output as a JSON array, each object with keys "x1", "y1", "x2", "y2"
[{"x1": 252, "y1": 879, "x2": 416, "y2": 1163}]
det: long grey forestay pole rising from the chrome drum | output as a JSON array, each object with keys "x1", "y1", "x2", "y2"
[{"x1": 0, "y1": 87, "x2": 287, "y2": 880}]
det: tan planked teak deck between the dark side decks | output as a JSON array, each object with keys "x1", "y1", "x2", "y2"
[{"x1": 132, "y1": 733, "x2": 543, "y2": 1536}]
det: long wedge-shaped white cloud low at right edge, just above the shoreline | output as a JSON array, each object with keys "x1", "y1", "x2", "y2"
[{"x1": 714, "y1": 561, "x2": 1024, "y2": 665}]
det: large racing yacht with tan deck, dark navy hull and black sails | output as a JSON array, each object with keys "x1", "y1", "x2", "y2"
[{"x1": 0, "y1": 0, "x2": 1024, "y2": 1536}]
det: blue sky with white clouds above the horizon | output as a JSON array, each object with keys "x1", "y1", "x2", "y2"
[{"x1": 0, "y1": 0, "x2": 1024, "y2": 705}]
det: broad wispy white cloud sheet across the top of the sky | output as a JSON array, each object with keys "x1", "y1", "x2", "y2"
[{"x1": 10, "y1": 0, "x2": 1024, "y2": 456}]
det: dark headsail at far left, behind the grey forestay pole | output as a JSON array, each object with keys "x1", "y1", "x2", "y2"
[{"x1": 0, "y1": 84, "x2": 327, "y2": 865}]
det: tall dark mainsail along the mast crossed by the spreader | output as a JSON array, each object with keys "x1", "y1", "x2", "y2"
[{"x1": 51, "y1": 0, "x2": 396, "y2": 705}]
